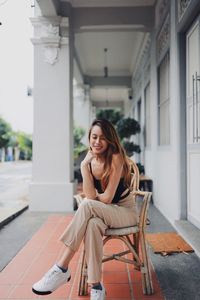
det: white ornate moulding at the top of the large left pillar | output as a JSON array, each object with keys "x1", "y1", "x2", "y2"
[{"x1": 31, "y1": 17, "x2": 69, "y2": 65}]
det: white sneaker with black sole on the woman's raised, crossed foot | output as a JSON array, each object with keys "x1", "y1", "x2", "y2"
[{"x1": 32, "y1": 265, "x2": 71, "y2": 295}]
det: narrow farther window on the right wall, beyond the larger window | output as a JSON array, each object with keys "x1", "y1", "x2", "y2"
[{"x1": 144, "y1": 83, "x2": 151, "y2": 147}]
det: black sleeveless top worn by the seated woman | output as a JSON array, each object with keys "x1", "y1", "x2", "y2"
[{"x1": 89, "y1": 163, "x2": 130, "y2": 203}]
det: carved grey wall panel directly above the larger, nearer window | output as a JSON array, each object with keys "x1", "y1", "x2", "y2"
[{"x1": 156, "y1": 14, "x2": 170, "y2": 61}]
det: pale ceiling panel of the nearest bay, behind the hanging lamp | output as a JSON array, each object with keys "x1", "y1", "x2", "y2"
[{"x1": 75, "y1": 31, "x2": 145, "y2": 76}]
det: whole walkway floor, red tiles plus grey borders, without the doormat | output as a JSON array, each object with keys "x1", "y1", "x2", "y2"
[{"x1": 0, "y1": 204, "x2": 200, "y2": 300}]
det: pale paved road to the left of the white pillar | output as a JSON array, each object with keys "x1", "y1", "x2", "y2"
[{"x1": 0, "y1": 161, "x2": 32, "y2": 222}]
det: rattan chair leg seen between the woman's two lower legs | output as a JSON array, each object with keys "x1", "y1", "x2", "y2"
[{"x1": 78, "y1": 250, "x2": 88, "y2": 296}]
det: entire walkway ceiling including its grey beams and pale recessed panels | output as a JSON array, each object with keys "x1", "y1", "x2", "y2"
[{"x1": 37, "y1": 0, "x2": 156, "y2": 107}]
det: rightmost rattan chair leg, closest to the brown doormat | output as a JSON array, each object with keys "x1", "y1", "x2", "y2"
[{"x1": 140, "y1": 232, "x2": 153, "y2": 295}]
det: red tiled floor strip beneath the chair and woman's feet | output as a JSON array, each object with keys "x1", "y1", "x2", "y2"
[{"x1": 0, "y1": 215, "x2": 164, "y2": 300}]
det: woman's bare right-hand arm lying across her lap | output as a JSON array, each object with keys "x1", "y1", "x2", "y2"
[{"x1": 97, "y1": 154, "x2": 123, "y2": 204}]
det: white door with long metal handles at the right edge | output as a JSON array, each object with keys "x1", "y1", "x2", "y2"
[{"x1": 186, "y1": 18, "x2": 200, "y2": 228}]
